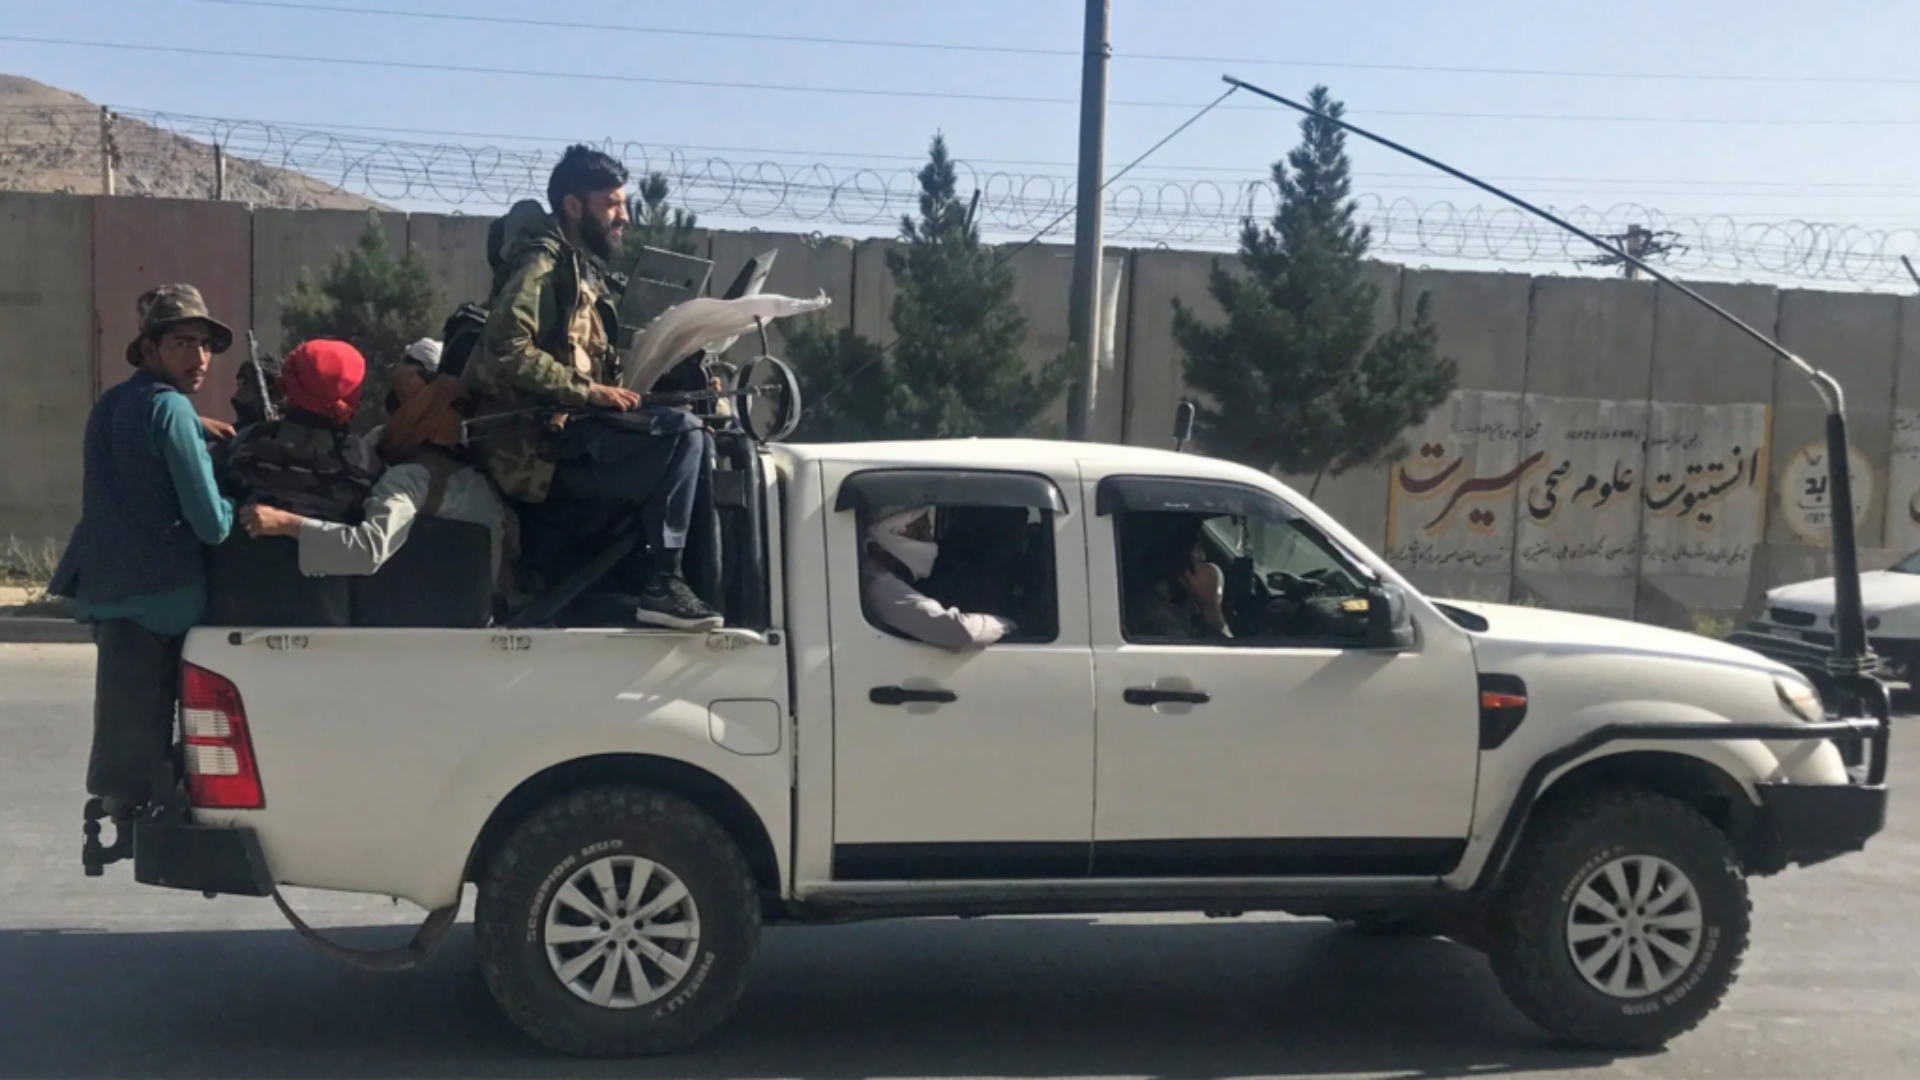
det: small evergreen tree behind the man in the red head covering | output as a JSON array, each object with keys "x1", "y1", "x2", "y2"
[{"x1": 280, "y1": 213, "x2": 445, "y2": 371}]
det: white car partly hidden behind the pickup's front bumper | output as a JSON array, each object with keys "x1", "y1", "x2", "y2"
[{"x1": 1738, "y1": 552, "x2": 1920, "y2": 686}]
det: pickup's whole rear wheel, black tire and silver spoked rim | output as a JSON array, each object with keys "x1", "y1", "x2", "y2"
[{"x1": 474, "y1": 788, "x2": 760, "y2": 1057}]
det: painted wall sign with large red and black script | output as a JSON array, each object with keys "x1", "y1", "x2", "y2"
[{"x1": 1388, "y1": 390, "x2": 1774, "y2": 578}]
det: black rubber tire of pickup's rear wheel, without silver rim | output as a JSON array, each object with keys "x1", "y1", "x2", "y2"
[{"x1": 474, "y1": 788, "x2": 760, "y2": 1057}]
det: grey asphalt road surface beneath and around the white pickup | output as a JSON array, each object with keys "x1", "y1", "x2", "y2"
[{"x1": 0, "y1": 646, "x2": 1920, "y2": 1080}]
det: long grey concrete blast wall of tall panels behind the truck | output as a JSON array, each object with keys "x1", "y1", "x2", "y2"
[{"x1": 0, "y1": 194, "x2": 1920, "y2": 625}]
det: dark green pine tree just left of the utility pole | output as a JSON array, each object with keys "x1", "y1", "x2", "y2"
[{"x1": 787, "y1": 135, "x2": 1069, "y2": 442}]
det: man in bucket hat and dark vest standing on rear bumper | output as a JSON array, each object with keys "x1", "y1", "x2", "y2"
[{"x1": 50, "y1": 284, "x2": 234, "y2": 819}]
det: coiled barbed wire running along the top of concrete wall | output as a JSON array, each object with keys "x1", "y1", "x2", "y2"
[{"x1": 0, "y1": 106, "x2": 1920, "y2": 288}]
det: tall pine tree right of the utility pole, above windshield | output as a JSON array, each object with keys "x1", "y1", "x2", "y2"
[{"x1": 1173, "y1": 86, "x2": 1457, "y2": 498}]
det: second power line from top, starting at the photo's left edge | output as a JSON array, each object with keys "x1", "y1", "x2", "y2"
[{"x1": 11, "y1": 35, "x2": 1920, "y2": 127}]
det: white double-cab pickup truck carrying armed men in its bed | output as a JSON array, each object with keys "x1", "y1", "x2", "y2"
[{"x1": 116, "y1": 428, "x2": 1887, "y2": 1055}]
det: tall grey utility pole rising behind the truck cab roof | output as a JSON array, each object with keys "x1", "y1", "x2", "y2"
[{"x1": 1068, "y1": 0, "x2": 1114, "y2": 440}]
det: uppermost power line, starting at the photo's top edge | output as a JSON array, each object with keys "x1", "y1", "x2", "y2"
[{"x1": 157, "y1": 0, "x2": 1920, "y2": 86}]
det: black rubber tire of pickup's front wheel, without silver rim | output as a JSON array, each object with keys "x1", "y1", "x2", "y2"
[{"x1": 1488, "y1": 790, "x2": 1753, "y2": 1051}]
